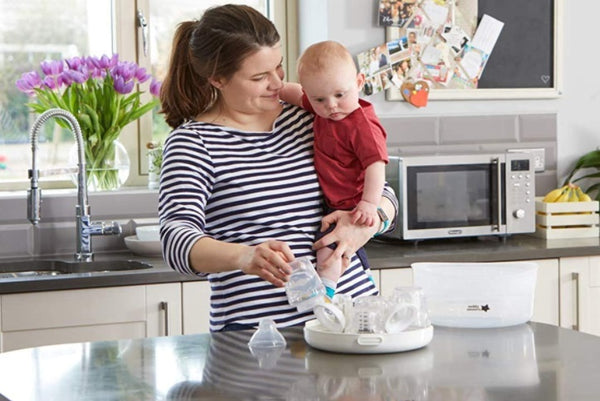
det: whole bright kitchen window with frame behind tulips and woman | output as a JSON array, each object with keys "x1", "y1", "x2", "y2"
[{"x1": 0, "y1": 0, "x2": 295, "y2": 190}]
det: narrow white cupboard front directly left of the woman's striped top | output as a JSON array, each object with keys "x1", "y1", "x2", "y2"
[{"x1": 181, "y1": 281, "x2": 210, "y2": 334}]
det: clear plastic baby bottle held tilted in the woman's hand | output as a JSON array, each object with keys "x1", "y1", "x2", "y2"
[{"x1": 285, "y1": 257, "x2": 326, "y2": 312}]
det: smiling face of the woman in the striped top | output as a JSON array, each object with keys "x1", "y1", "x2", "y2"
[{"x1": 212, "y1": 44, "x2": 284, "y2": 114}]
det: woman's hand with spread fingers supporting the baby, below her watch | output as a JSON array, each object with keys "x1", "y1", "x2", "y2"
[{"x1": 313, "y1": 210, "x2": 378, "y2": 270}]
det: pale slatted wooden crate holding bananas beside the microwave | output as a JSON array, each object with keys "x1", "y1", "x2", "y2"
[{"x1": 535, "y1": 197, "x2": 600, "y2": 239}]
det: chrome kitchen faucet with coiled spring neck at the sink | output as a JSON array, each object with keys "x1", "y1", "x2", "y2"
[{"x1": 27, "y1": 108, "x2": 121, "y2": 262}]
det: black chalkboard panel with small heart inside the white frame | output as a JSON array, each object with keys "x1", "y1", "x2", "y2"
[{"x1": 477, "y1": 0, "x2": 555, "y2": 88}]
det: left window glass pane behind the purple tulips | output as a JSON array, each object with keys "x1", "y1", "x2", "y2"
[{"x1": 0, "y1": 0, "x2": 113, "y2": 189}]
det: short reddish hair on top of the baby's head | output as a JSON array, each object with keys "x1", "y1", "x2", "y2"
[{"x1": 297, "y1": 40, "x2": 356, "y2": 76}]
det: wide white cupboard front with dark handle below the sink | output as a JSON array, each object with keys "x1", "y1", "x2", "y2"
[{"x1": 0, "y1": 283, "x2": 181, "y2": 352}]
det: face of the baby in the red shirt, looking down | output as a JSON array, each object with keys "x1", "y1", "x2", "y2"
[{"x1": 300, "y1": 63, "x2": 364, "y2": 121}]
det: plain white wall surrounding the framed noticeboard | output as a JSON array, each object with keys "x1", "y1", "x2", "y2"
[{"x1": 299, "y1": 0, "x2": 600, "y2": 182}]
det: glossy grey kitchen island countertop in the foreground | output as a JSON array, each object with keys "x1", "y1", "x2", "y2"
[{"x1": 0, "y1": 323, "x2": 600, "y2": 401}]
